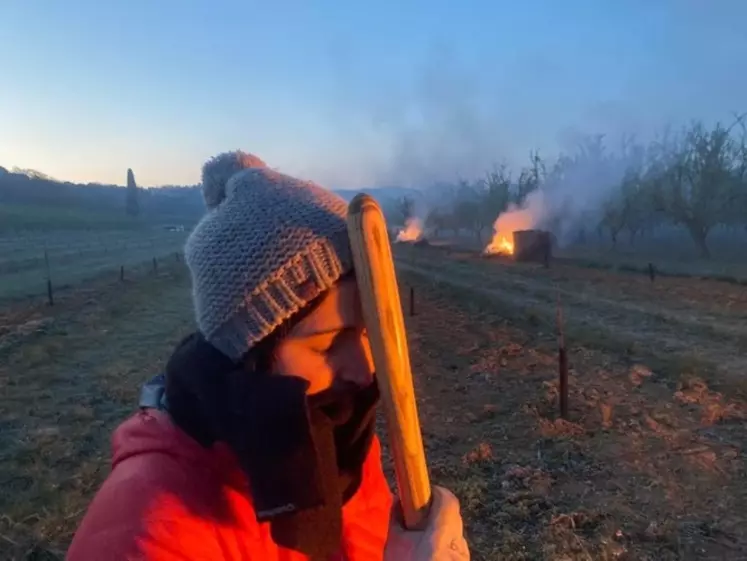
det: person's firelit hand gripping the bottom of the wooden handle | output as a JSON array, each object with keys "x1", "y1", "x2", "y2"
[{"x1": 384, "y1": 487, "x2": 469, "y2": 561}]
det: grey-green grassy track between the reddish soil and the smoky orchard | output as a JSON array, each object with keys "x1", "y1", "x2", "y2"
[{"x1": 398, "y1": 247, "x2": 747, "y2": 396}]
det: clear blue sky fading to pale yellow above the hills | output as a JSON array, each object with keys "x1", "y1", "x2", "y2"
[{"x1": 0, "y1": 0, "x2": 747, "y2": 187}]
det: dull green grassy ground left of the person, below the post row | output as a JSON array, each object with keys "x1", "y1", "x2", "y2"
[{"x1": 0, "y1": 267, "x2": 192, "y2": 561}]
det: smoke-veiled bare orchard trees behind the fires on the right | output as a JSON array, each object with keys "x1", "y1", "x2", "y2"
[{"x1": 390, "y1": 115, "x2": 747, "y2": 258}]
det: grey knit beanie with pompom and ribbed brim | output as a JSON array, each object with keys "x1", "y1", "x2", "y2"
[{"x1": 185, "y1": 151, "x2": 353, "y2": 361}]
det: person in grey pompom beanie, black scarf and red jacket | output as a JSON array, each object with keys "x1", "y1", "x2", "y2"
[{"x1": 67, "y1": 151, "x2": 469, "y2": 561}]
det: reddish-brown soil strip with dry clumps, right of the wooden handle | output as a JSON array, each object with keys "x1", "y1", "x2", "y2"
[{"x1": 400, "y1": 266, "x2": 747, "y2": 561}]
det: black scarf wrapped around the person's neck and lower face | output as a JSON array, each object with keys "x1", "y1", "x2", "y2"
[{"x1": 161, "y1": 334, "x2": 379, "y2": 559}]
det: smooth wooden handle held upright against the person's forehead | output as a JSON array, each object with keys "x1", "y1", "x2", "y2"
[{"x1": 348, "y1": 194, "x2": 431, "y2": 530}]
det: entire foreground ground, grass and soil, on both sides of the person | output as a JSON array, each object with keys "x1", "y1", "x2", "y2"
[{"x1": 0, "y1": 253, "x2": 747, "y2": 561}]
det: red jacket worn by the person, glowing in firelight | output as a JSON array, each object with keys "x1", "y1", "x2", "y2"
[{"x1": 67, "y1": 410, "x2": 392, "y2": 561}]
